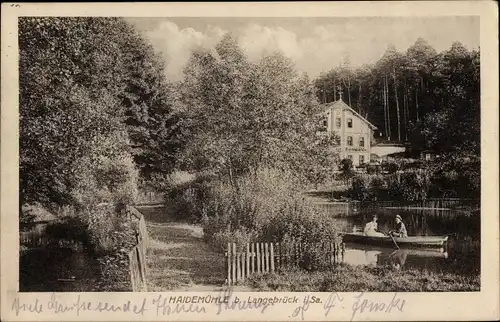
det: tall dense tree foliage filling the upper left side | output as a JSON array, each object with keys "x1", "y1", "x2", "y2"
[{"x1": 19, "y1": 17, "x2": 181, "y2": 207}]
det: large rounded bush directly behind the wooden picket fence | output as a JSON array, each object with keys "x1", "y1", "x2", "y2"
[{"x1": 200, "y1": 171, "x2": 337, "y2": 262}]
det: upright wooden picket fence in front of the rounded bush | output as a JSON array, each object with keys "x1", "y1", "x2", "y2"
[{"x1": 225, "y1": 242, "x2": 345, "y2": 285}]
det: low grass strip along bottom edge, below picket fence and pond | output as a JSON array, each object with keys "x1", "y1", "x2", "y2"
[{"x1": 245, "y1": 265, "x2": 481, "y2": 292}]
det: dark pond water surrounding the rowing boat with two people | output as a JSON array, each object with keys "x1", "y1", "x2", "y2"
[{"x1": 320, "y1": 208, "x2": 481, "y2": 275}]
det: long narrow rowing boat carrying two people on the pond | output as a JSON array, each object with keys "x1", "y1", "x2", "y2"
[{"x1": 342, "y1": 232, "x2": 448, "y2": 247}]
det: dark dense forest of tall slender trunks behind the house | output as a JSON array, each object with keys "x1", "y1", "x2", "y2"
[{"x1": 314, "y1": 38, "x2": 480, "y2": 155}]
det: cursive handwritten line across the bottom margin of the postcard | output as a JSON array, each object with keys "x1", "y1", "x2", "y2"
[{"x1": 11, "y1": 288, "x2": 406, "y2": 321}]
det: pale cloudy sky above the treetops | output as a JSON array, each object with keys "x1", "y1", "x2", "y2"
[{"x1": 128, "y1": 16, "x2": 480, "y2": 80}]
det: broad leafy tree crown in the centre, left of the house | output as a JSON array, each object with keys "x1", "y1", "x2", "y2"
[{"x1": 181, "y1": 34, "x2": 334, "y2": 189}]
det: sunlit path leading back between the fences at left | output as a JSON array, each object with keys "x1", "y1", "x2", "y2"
[{"x1": 137, "y1": 205, "x2": 249, "y2": 292}]
